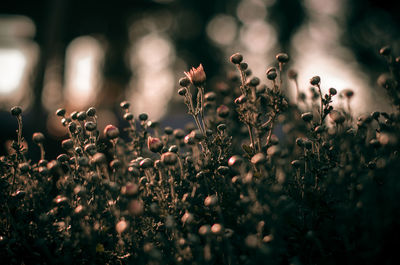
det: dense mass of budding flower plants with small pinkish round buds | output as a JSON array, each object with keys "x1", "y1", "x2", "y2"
[{"x1": 0, "y1": 47, "x2": 400, "y2": 265}]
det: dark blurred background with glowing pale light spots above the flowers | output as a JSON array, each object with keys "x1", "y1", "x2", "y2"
[{"x1": 0, "y1": 0, "x2": 400, "y2": 159}]
